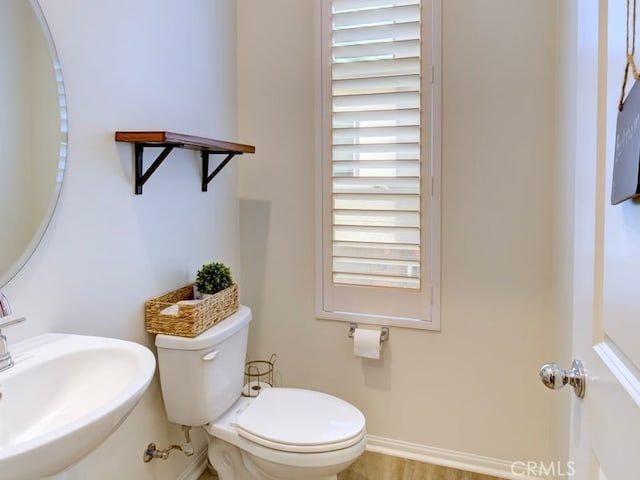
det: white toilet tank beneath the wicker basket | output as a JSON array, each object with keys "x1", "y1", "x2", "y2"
[{"x1": 156, "y1": 305, "x2": 251, "y2": 426}]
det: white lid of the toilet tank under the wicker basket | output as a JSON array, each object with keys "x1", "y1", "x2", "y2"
[{"x1": 156, "y1": 305, "x2": 251, "y2": 350}]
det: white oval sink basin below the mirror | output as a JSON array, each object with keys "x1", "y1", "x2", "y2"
[{"x1": 0, "y1": 333, "x2": 155, "y2": 480}]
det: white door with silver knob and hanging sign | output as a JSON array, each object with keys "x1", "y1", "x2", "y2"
[{"x1": 556, "y1": 0, "x2": 640, "y2": 480}]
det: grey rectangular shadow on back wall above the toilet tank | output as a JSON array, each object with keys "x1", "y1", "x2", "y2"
[{"x1": 240, "y1": 199, "x2": 271, "y2": 338}]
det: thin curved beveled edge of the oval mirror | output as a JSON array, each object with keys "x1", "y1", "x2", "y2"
[{"x1": 0, "y1": 0, "x2": 68, "y2": 288}]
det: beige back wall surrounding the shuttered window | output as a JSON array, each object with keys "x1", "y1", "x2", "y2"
[{"x1": 238, "y1": 0, "x2": 556, "y2": 461}]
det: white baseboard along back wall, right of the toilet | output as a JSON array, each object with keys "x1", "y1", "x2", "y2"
[{"x1": 367, "y1": 435, "x2": 540, "y2": 480}]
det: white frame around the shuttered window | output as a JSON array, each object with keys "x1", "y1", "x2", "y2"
[{"x1": 316, "y1": 0, "x2": 441, "y2": 330}]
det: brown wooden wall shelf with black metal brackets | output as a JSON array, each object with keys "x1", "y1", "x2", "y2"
[{"x1": 116, "y1": 131, "x2": 256, "y2": 195}]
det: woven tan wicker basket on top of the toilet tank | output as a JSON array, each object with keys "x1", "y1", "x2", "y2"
[{"x1": 145, "y1": 284, "x2": 239, "y2": 337}]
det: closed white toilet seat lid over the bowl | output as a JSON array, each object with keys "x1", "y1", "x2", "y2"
[{"x1": 235, "y1": 388, "x2": 365, "y2": 452}]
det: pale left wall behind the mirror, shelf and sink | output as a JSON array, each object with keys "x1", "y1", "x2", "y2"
[{"x1": 3, "y1": 0, "x2": 240, "y2": 480}]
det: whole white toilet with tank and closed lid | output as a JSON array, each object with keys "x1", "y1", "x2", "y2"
[{"x1": 156, "y1": 306, "x2": 367, "y2": 480}]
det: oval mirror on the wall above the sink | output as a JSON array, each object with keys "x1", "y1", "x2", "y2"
[{"x1": 0, "y1": 0, "x2": 67, "y2": 287}]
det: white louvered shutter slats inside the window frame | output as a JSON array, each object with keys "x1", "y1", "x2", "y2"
[{"x1": 330, "y1": 0, "x2": 422, "y2": 290}]
